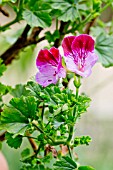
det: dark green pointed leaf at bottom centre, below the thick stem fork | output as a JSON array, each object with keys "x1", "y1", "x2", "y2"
[{"x1": 54, "y1": 156, "x2": 77, "y2": 170}]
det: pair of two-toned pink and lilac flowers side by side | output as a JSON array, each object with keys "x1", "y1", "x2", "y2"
[{"x1": 36, "y1": 34, "x2": 98, "y2": 87}]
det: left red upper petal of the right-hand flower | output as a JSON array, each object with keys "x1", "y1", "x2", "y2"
[{"x1": 62, "y1": 36, "x2": 75, "y2": 56}]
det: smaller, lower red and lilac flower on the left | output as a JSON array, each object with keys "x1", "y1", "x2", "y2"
[{"x1": 36, "y1": 47, "x2": 66, "y2": 87}]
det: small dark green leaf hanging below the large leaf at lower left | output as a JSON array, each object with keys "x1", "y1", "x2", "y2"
[{"x1": 5, "y1": 133, "x2": 22, "y2": 149}]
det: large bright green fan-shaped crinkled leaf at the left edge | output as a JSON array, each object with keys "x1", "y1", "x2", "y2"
[{"x1": 1, "y1": 96, "x2": 37, "y2": 123}]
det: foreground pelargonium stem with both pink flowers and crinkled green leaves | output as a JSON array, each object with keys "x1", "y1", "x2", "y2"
[{"x1": 0, "y1": 34, "x2": 97, "y2": 170}]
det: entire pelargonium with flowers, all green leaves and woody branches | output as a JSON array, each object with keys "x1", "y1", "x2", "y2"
[{"x1": 0, "y1": 0, "x2": 113, "y2": 170}]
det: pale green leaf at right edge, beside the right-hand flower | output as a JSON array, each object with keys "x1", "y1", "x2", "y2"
[{"x1": 95, "y1": 33, "x2": 113, "y2": 67}]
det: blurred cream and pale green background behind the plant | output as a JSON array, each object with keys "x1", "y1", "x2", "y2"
[{"x1": 0, "y1": 2, "x2": 113, "y2": 170}]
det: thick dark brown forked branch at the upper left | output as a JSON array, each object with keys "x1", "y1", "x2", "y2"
[{"x1": 0, "y1": 25, "x2": 45, "y2": 65}]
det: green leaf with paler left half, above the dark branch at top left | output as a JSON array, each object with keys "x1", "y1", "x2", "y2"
[{"x1": 23, "y1": 9, "x2": 51, "y2": 28}]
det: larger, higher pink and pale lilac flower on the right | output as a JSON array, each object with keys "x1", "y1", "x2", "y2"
[{"x1": 62, "y1": 34, "x2": 98, "y2": 77}]
